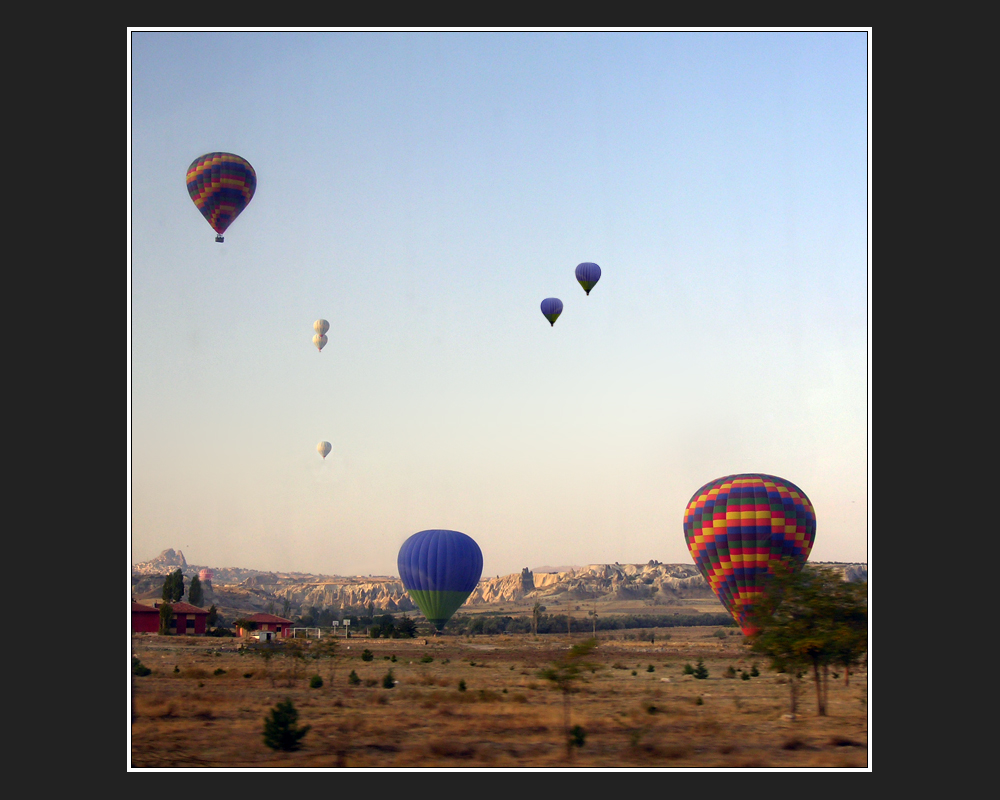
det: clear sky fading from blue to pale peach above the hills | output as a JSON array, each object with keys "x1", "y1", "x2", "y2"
[{"x1": 128, "y1": 29, "x2": 871, "y2": 575}]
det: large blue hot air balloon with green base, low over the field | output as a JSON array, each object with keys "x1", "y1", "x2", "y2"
[{"x1": 396, "y1": 530, "x2": 483, "y2": 630}]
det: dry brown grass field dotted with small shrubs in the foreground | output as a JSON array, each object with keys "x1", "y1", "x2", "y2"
[{"x1": 130, "y1": 627, "x2": 868, "y2": 770}]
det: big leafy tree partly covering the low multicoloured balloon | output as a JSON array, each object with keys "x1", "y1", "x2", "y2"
[{"x1": 749, "y1": 562, "x2": 868, "y2": 716}]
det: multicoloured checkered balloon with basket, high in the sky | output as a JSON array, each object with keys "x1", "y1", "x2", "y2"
[{"x1": 187, "y1": 153, "x2": 257, "y2": 242}]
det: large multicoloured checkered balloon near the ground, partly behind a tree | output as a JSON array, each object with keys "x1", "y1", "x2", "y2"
[{"x1": 684, "y1": 473, "x2": 816, "y2": 636}]
